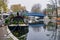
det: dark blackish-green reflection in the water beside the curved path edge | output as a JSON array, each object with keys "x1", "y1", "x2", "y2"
[{"x1": 9, "y1": 26, "x2": 28, "y2": 40}]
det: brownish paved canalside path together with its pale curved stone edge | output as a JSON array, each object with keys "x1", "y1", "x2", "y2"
[{"x1": 0, "y1": 26, "x2": 18, "y2": 40}]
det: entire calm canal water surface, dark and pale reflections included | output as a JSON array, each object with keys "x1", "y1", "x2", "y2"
[{"x1": 8, "y1": 22, "x2": 60, "y2": 40}]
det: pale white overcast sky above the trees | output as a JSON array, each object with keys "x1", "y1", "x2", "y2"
[{"x1": 8, "y1": 0, "x2": 49, "y2": 11}]
